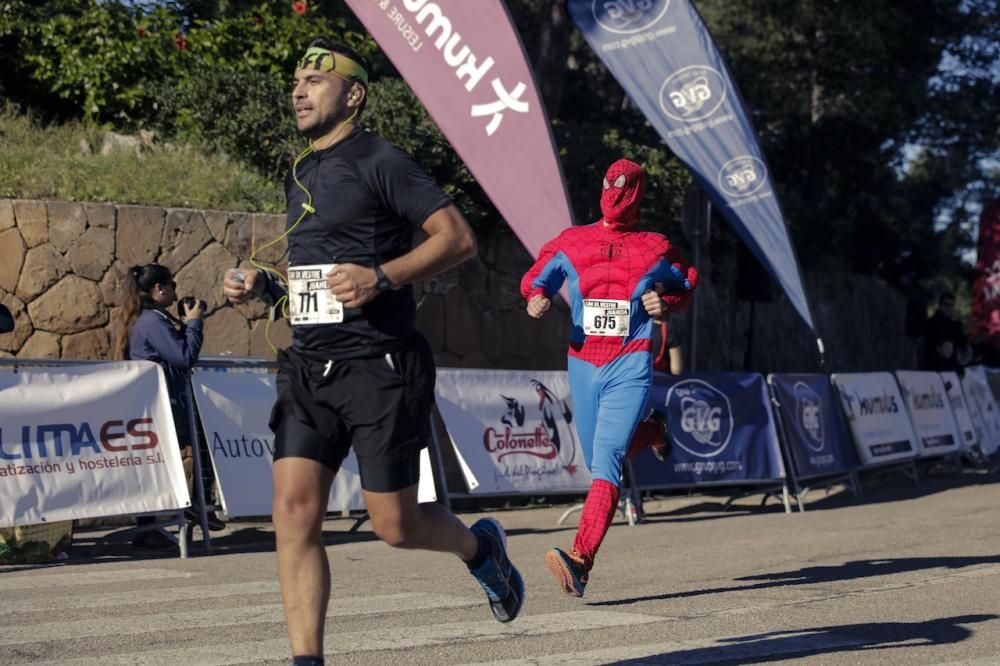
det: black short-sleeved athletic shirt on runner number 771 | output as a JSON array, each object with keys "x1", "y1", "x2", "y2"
[{"x1": 285, "y1": 127, "x2": 451, "y2": 359}]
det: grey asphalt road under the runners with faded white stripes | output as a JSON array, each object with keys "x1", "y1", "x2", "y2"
[{"x1": 0, "y1": 472, "x2": 1000, "y2": 666}]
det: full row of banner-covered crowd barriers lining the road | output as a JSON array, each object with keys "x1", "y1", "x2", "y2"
[{"x1": 0, "y1": 357, "x2": 1000, "y2": 557}]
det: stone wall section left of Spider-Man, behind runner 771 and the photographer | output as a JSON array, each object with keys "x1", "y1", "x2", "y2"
[{"x1": 0, "y1": 199, "x2": 568, "y2": 369}]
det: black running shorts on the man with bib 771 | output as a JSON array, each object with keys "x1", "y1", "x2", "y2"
[{"x1": 270, "y1": 335, "x2": 435, "y2": 493}]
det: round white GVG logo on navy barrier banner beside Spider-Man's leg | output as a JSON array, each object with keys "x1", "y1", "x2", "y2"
[{"x1": 667, "y1": 379, "x2": 733, "y2": 458}]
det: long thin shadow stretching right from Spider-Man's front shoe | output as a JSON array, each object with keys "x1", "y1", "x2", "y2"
[{"x1": 587, "y1": 555, "x2": 1000, "y2": 606}]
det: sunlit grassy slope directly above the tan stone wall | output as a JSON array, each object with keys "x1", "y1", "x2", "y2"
[{"x1": 0, "y1": 107, "x2": 284, "y2": 213}]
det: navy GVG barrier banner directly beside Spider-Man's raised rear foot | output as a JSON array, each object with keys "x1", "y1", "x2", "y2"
[{"x1": 632, "y1": 373, "x2": 785, "y2": 488}]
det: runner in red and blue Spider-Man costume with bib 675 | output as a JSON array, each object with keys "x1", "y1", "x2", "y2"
[{"x1": 521, "y1": 159, "x2": 698, "y2": 597}]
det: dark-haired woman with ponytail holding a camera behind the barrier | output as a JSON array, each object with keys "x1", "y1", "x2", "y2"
[{"x1": 112, "y1": 264, "x2": 205, "y2": 550}]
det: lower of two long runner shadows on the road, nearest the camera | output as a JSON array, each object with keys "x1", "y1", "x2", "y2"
[{"x1": 613, "y1": 615, "x2": 998, "y2": 666}]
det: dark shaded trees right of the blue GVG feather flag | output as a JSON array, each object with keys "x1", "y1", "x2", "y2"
[{"x1": 684, "y1": 0, "x2": 1000, "y2": 295}]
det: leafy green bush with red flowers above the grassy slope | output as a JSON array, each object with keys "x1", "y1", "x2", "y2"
[{"x1": 0, "y1": 0, "x2": 374, "y2": 127}]
